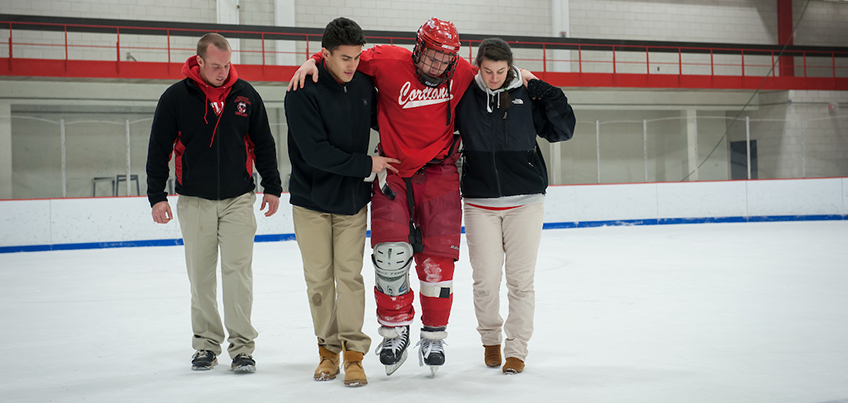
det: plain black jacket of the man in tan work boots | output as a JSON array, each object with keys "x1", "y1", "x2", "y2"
[{"x1": 285, "y1": 63, "x2": 377, "y2": 215}]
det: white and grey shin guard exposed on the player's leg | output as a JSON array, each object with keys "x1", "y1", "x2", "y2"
[{"x1": 371, "y1": 242, "x2": 412, "y2": 297}]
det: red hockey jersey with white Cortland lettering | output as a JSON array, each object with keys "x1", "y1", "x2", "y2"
[{"x1": 313, "y1": 45, "x2": 476, "y2": 178}]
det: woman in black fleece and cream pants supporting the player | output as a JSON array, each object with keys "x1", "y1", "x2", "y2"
[{"x1": 456, "y1": 38, "x2": 576, "y2": 374}]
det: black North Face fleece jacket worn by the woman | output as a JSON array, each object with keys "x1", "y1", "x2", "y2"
[{"x1": 456, "y1": 80, "x2": 576, "y2": 198}]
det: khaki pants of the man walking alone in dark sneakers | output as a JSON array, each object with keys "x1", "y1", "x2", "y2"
[{"x1": 177, "y1": 192, "x2": 258, "y2": 358}]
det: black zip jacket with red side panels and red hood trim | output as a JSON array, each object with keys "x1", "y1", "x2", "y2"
[{"x1": 147, "y1": 78, "x2": 283, "y2": 206}]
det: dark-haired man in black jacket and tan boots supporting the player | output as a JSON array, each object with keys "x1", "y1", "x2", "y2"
[{"x1": 285, "y1": 17, "x2": 400, "y2": 386}]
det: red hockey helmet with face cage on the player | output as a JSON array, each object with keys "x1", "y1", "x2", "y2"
[{"x1": 412, "y1": 17, "x2": 459, "y2": 87}]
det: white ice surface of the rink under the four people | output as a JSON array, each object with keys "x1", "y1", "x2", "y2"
[{"x1": 0, "y1": 221, "x2": 848, "y2": 403}]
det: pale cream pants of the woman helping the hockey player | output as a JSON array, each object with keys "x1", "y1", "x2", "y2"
[{"x1": 464, "y1": 203, "x2": 544, "y2": 361}]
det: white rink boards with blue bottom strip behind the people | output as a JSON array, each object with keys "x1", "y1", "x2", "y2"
[{"x1": 0, "y1": 178, "x2": 848, "y2": 252}]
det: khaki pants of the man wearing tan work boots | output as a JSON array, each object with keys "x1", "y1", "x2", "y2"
[{"x1": 292, "y1": 206, "x2": 371, "y2": 353}]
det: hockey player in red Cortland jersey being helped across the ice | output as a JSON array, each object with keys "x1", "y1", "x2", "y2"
[{"x1": 289, "y1": 17, "x2": 532, "y2": 375}]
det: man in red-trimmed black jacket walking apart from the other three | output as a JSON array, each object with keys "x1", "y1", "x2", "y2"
[{"x1": 147, "y1": 34, "x2": 282, "y2": 372}]
